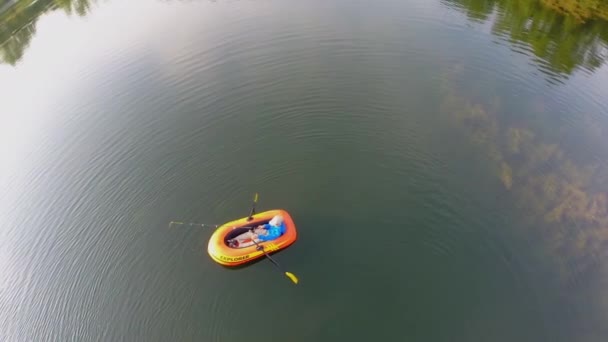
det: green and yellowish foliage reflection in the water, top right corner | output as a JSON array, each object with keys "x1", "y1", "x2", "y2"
[{"x1": 446, "y1": 0, "x2": 608, "y2": 79}]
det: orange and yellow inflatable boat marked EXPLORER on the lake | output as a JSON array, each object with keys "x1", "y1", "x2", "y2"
[{"x1": 207, "y1": 209, "x2": 297, "y2": 266}]
